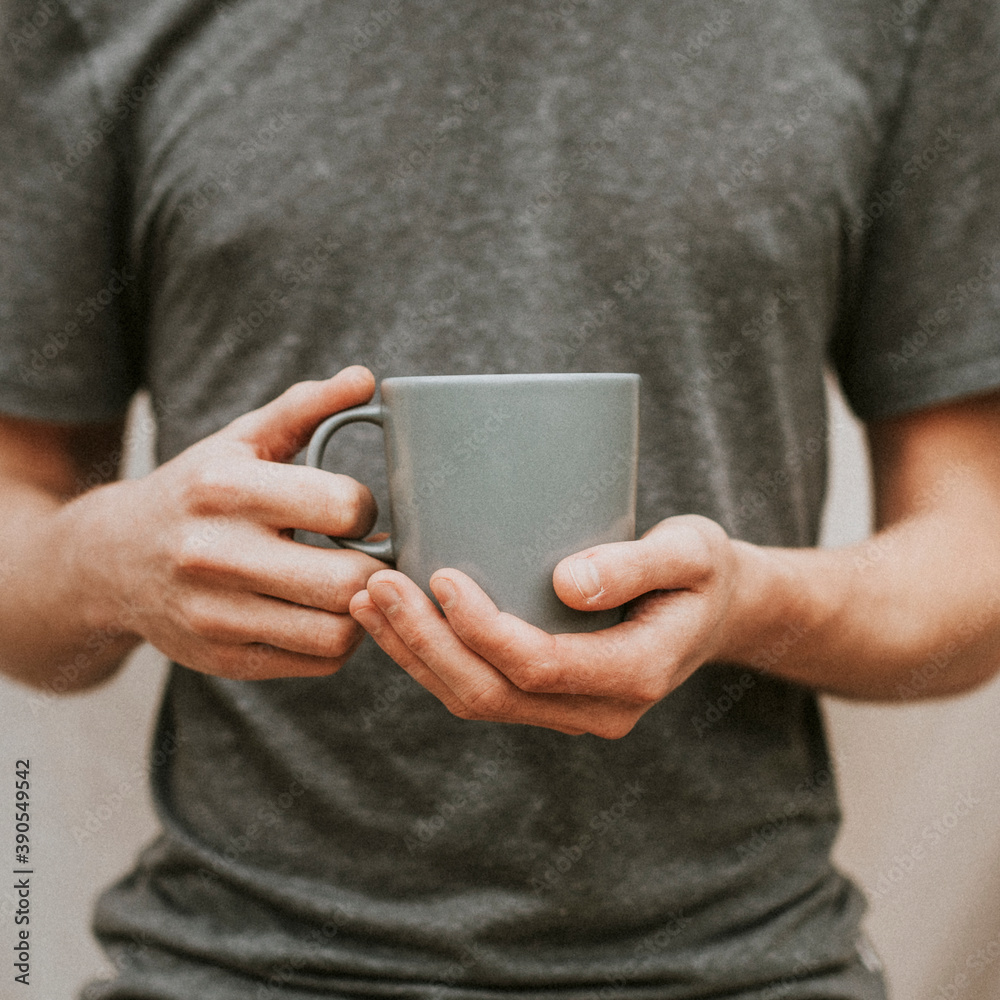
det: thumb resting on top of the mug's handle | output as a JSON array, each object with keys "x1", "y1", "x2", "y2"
[{"x1": 222, "y1": 365, "x2": 375, "y2": 462}]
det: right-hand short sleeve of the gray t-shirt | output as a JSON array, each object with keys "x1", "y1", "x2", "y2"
[{"x1": 833, "y1": 0, "x2": 1000, "y2": 419}]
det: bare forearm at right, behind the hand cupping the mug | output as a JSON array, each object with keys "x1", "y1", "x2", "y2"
[{"x1": 723, "y1": 496, "x2": 1000, "y2": 700}]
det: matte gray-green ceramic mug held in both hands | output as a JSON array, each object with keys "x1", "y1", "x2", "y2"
[{"x1": 306, "y1": 373, "x2": 639, "y2": 633}]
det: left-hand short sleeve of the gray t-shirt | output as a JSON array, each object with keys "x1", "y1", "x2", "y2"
[{"x1": 0, "y1": 0, "x2": 138, "y2": 422}]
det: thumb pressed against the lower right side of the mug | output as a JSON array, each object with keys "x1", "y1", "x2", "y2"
[{"x1": 552, "y1": 514, "x2": 732, "y2": 611}]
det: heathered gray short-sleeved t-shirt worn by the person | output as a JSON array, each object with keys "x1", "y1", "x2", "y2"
[{"x1": 0, "y1": 0, "x2": 1000, "y2": 1000}]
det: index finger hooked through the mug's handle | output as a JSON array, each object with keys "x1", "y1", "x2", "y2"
[{"x1": 185, "y1": 460, "x2": 378, "y2": 538}]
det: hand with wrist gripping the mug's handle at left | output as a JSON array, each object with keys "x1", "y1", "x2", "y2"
[{"x1": 0, "y1": 367, "x2": 384, "y2": 687}]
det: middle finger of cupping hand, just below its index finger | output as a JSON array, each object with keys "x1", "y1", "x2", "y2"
[{"x1": 367, "y1": 570, "x2": 637, "y2": 735}]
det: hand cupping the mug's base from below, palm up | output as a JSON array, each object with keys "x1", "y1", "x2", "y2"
[{"x1": 350, "y1": 515, "x2": 741, "y2": 739}]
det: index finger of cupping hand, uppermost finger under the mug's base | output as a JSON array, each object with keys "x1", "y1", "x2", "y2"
[{"x1": 430, "y1": 569, "x2": 688, "y2": 706}]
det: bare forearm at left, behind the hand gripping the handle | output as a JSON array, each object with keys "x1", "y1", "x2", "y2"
[{"x1": 0, "y1": 481, "x2": 140, "y2": 693}]
